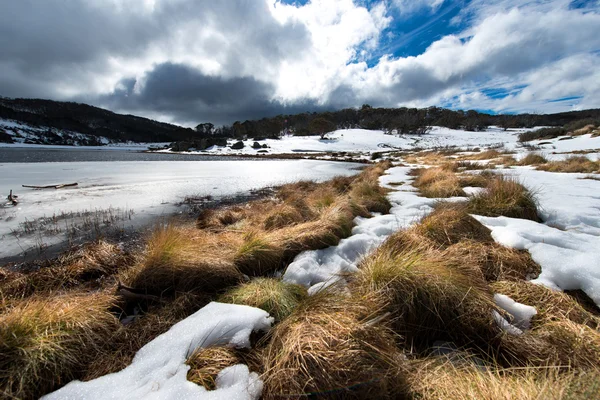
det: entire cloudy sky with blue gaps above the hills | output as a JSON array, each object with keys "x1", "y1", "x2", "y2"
[{"x1": 0, "y1": 0, "x2": 600, "y2": 125}]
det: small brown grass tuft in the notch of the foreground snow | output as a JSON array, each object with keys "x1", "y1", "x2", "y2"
[{"x1": 186, "y1": 346, "x2": 242, "y2": 390}]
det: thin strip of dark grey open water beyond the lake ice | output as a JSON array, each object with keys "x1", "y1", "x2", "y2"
[{"x1": 0, "y1": 147, "x2": 247, "y2": 163}]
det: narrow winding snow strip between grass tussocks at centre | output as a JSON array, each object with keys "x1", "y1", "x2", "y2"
[{"x1": 283, "y1": 167, "x2": 435, "y2": 294}]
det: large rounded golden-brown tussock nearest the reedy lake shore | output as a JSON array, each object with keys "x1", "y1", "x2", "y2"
[{"x1": 123, "y1": 225, "x2": 242, "y2": 296}]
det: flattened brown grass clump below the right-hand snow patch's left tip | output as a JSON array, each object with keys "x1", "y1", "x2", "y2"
[{"x1": 445, "y1": 240, "x2": 541, "y2": 282}]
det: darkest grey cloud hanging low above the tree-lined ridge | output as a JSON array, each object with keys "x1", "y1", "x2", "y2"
[{"x1": 92, "y1": 63, "x2": 325, "y2": 124}]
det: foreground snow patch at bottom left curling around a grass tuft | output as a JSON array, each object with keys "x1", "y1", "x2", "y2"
[{"x1": 42, "y1": 302, "x2": 273, "y2": 400}]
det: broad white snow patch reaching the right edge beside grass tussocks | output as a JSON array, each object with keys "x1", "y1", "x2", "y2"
[{"x1": 475, "y1": 167, "x2": 600, "y2": 306}]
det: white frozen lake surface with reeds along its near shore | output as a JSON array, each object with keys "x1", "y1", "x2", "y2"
[{"x1": 0, "y1": 159, "x2": 360, "y2": 261}]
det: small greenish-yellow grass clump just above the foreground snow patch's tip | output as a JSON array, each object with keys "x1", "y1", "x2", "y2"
[{"x1": 219, "y1": 278, "x2": 308, "y2": 321}]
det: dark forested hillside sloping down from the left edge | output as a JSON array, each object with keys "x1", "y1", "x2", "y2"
[{"x1": 0, "y1": 97, "x2": 195, "y2": 142}]
